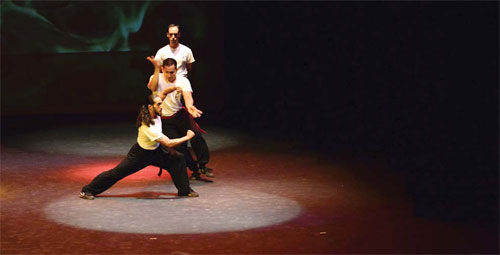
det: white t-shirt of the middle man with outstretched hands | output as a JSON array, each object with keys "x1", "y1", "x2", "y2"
[{"x1": 149, "y1": 73, "x2": 193, "y2": 117}]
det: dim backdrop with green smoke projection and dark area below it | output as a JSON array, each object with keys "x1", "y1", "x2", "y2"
[{"x1": 0, "y1": 1, "x2": 222, "y2": 115}]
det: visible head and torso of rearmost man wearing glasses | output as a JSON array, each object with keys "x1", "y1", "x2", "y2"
[{"x1": 155, "y1": 24, "x2": 195, "y2": 78}]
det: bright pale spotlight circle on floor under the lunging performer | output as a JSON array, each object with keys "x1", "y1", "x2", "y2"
[{"x1": 44, "y1": 185, "x2": 301, "y2": 234}]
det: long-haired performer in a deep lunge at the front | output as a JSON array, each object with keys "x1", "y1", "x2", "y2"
[{"x1": 80, "y1": 92, "x2": 198, "y2": 199}]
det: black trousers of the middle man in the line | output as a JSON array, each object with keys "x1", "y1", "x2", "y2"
[{"x1": 161, "y1": 108, "x2": 210, "y2": 173}]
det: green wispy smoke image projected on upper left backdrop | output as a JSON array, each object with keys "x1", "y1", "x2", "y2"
[{"x1": 2, "y1": 1, "x2": 149, "y2": 53}]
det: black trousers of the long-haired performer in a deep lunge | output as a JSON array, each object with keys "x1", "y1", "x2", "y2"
[{"x1": 82, "y1": 143, "x2": 190, "y2": 195}]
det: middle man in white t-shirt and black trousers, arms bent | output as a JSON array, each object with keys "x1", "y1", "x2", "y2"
[{"x1": 147, "y1": 56, "x2": 213, "y2": 180}]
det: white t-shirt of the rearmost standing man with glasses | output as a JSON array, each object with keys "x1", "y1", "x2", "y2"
[{"x1": 155, "y1": 43, "x2": 195, "y2": 77}]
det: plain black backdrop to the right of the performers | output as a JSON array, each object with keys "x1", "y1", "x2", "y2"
[{"x1": 224, "y1": 2, "x2": 499, "y2": 225}]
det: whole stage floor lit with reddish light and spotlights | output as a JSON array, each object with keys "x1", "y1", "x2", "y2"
[{"x1": 0, "y1": 121, "x2": 498, "y2": 254}]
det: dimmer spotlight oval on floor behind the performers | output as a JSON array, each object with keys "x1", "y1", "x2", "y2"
[{"x1": 11, "y1": 123, "x2": 244, "y2": 156}]
